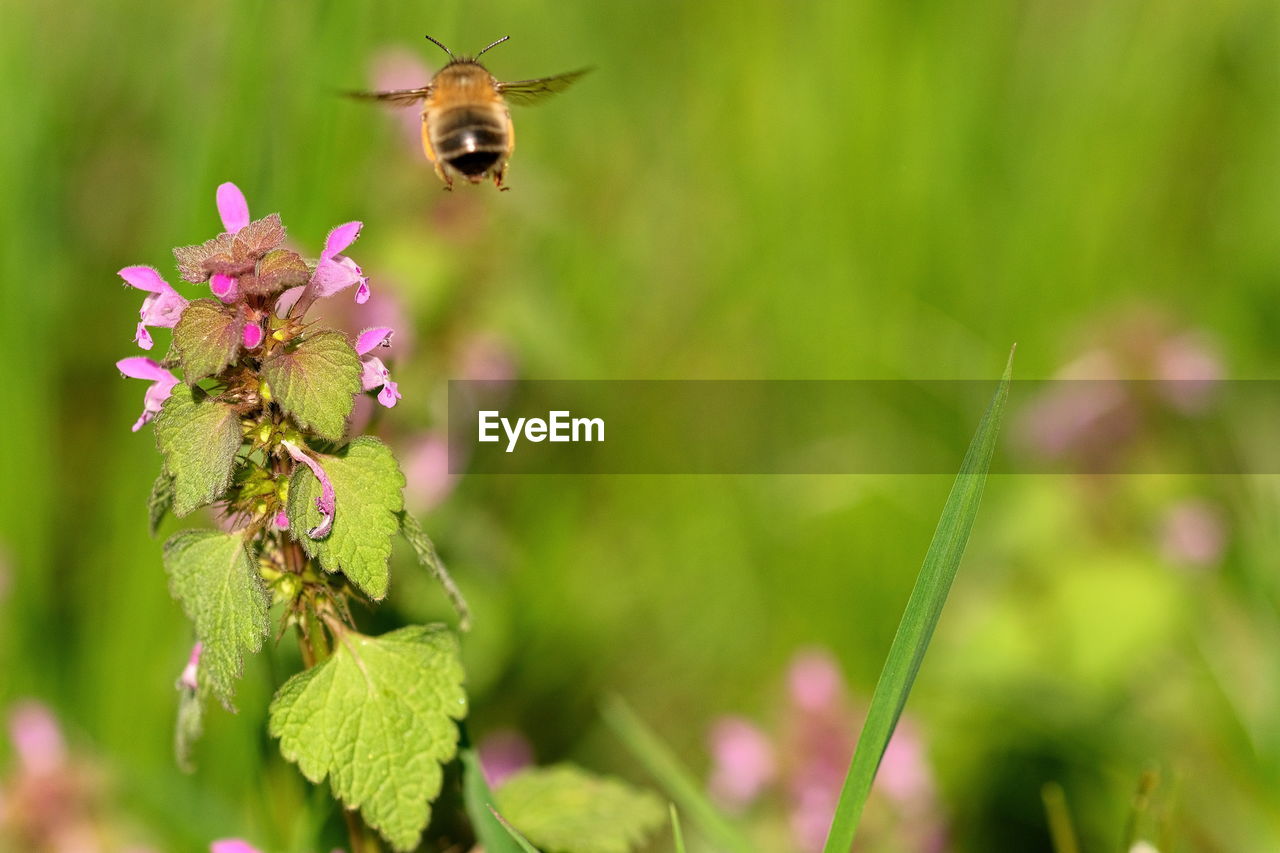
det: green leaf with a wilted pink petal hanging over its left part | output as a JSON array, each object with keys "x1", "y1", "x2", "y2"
[{"x1": 288, "y1": 435, "x2": 404, "y2": 599}]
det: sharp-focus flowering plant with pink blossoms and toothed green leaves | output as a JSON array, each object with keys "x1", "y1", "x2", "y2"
[{"x1": 118, "y1": 183, "x2": 467, "y2": 849}]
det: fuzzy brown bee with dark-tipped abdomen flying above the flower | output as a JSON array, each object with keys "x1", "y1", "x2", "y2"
[{"x1": 351, "y1": 36, "x2": 591, "y2": 190}]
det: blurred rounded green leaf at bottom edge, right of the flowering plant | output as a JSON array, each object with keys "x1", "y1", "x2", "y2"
[{"x1": 498, "y1": 765, "x2": 666, "y2": 853}]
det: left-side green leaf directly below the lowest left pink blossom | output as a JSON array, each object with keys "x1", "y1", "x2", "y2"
[{"x1": 155, "y1": 384, "x2": 243, "y2": 516}]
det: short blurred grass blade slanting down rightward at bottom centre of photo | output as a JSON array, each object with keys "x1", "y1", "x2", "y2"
[{"x1": 600, "y1": 697, "x2": 753, "y2": 853}]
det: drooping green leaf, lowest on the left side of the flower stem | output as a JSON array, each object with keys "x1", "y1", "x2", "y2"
[{"x1": 164, "y1": 530, "x2": 270, "y2": 710}]
